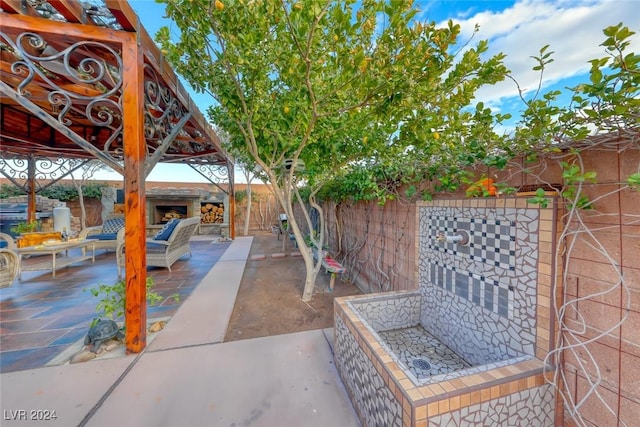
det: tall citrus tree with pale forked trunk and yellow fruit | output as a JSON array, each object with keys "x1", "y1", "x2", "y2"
[{"x1": 156, "y1": 0, "x2": 507, "y2": 301}]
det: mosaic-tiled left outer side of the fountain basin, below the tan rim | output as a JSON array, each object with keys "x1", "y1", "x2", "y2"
[{"x1": 334, "y1": 316, "x2": 403, "y2": 427}]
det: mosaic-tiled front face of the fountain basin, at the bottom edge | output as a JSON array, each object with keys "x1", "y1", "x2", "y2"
[{"x1": 428, "y1": 385, "x2": 555, "y2": 427}]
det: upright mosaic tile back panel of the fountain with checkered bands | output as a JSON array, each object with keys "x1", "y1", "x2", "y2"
[{"x1": 417, "y1": 201, "x2": 540, "y2": 365}]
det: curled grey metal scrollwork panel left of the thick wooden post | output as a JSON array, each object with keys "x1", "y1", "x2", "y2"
[{"x1": 0, "y1": 32, "x2": 124, "y2": 159}]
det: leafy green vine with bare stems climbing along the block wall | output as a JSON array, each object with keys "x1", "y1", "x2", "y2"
[{"x1": 320, "y1": 24, "x2": 640, "y2": 426}]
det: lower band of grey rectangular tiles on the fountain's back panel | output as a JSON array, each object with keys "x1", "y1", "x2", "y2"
[{"x1": 430, "y1": 262, "x2": 514, "y2": 319}]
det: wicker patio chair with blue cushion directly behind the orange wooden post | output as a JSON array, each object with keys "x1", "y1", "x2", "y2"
[{"x1": 116, "y1": 216, "x2": 200, "y2": 278}]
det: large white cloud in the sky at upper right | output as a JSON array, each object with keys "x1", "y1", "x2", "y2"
[{"x1": 432, "y1": 0, "x2": 640, "y2": 105}]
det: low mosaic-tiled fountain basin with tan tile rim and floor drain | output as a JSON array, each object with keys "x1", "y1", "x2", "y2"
[{"x1": 335, "y1": 291, "x2": 555, "y2": 426}]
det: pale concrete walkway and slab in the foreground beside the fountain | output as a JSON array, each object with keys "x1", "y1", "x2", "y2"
[{"x1": 0, "y1": 237, "x2": 360, "y2": 426}]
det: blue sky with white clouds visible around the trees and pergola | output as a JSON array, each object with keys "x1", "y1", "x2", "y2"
[{"x1": 92, "y1": 0, "x2": 640, "y2": 182}]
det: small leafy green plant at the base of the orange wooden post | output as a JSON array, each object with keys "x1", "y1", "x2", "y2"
[{"x1": 87, "y1": 277, "x2": 180, "y2": 326}]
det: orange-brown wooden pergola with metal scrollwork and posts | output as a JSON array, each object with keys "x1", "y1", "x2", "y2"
[{"x1": 0, "y1": 0, "x2": 234, "y2": 352}]
